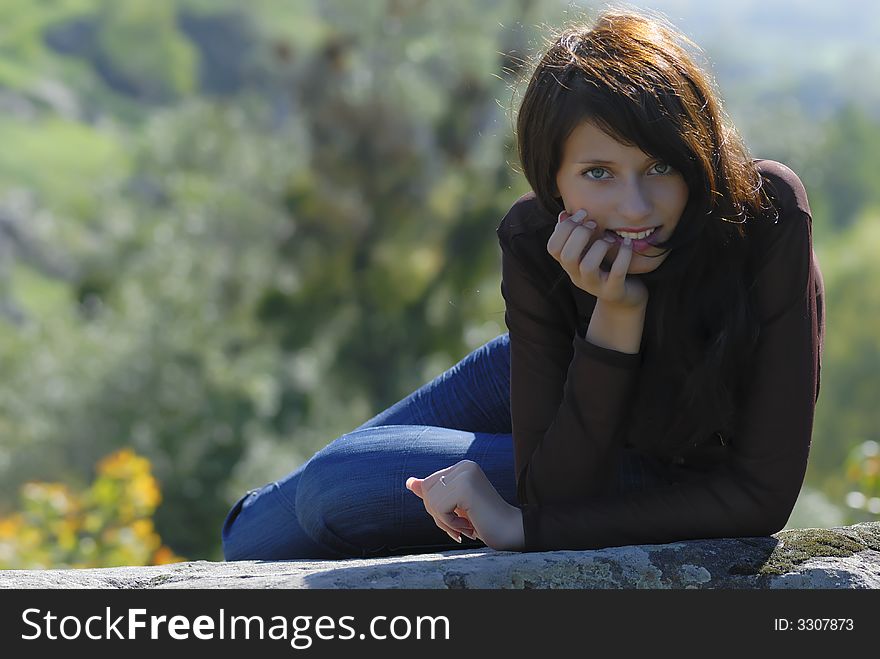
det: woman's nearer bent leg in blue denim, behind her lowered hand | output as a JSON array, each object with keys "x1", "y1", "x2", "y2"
[{"x1": 296, "y1": 425, "x2": 516, "y2": 558}]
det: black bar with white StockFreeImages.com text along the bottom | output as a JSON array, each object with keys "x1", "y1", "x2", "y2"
[{"x1": 0, "y1": 589, "x2": 880, "y2": 659}]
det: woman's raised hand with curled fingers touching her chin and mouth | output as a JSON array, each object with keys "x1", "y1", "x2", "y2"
[{"x1": 547, "y1": 210, "x2": 648, "y2": 309}]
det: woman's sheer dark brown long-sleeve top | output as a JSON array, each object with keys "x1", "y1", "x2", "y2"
[{"x1": 497, "y1": 160, "x2": 824, "y2": 551}]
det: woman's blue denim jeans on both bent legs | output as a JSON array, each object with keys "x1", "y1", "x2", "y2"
[{"x1": 222, "y1": 334, "x2": 663, "y2": 561}]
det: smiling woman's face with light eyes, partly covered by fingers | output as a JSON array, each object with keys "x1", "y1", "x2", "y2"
[{"x1": 556, "y1": 122, "x2": 688, "y2": 274}]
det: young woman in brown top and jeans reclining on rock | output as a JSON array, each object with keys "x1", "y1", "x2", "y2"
[{"x1": 223, "y1": 7, "x2": 824, "y2": 560}]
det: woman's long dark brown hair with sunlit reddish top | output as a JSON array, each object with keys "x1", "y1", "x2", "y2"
[{"x1": 516, "y1": 10, "x2": 773, "y2": 462}]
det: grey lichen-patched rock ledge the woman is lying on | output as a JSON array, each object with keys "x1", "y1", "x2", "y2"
[{"x1": 0, "y1": 522, "x2": 880, "y2": 589}]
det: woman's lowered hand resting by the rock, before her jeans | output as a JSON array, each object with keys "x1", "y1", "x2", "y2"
[{"x1": 406, "y1": 460, "x2": 525, "y2": 551}]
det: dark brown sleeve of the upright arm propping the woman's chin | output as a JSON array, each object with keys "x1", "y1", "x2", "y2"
[{"x1": 498, "y1": 209, "x2": 640, "y2": 504}]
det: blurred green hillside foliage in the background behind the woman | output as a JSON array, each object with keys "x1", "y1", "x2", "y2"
[{"x1": 0, "y1": 0, "x2": 880, "y2": 564}]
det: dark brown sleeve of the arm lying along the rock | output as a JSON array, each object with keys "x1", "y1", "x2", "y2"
[{"x1": 522, "y1": 164, "x2": 824, "y2": 551}]
